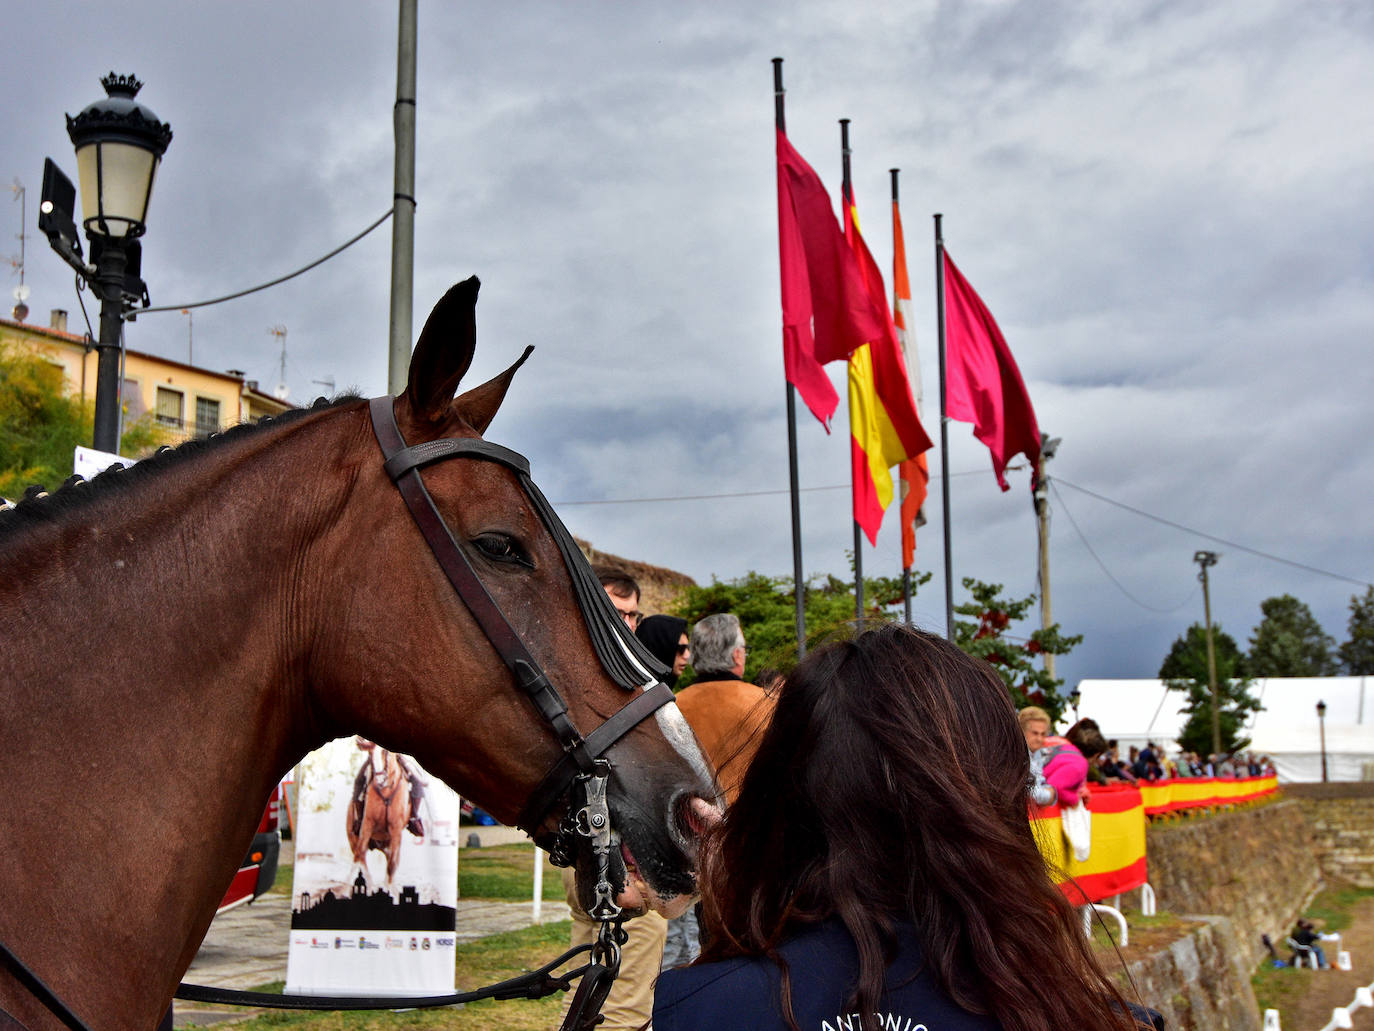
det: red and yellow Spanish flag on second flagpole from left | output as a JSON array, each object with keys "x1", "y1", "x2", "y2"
[{"x1": 844, "y1": 188, "x2": 930, "y2": 544}]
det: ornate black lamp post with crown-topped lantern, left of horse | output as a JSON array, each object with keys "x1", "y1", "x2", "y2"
[{"x1": 67, "y1": 71, "x2": 172, "y2": 454}]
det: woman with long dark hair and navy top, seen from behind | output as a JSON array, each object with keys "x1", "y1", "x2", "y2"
[{"x1": 654, "y1": 625, "x2": 1149, "y2": 1031}]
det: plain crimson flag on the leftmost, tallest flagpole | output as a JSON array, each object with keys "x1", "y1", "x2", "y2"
[{"x1": 778, "y1": 131, "x2": 886, "y2": 432}]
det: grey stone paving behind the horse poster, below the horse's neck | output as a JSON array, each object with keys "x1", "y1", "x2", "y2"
[{"x1": 176, "y1": 828, "x2": 569, "y2": 1027}]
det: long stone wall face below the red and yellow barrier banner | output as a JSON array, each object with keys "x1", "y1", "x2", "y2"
[{"x1": 1146, "y1": 799, "x2": 1322, "y2": 971}]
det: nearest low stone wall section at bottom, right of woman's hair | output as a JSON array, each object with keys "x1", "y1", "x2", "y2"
[{"x1": 1125, "y1": 917, "x2": 1260, "y2": 1031}]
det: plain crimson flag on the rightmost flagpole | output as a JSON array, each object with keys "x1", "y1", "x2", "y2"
[{"x1": 944, "y1": 252, "x2": 1040, "y2": 491}]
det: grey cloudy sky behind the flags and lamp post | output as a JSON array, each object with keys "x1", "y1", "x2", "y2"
[{"x1": 0, "y1": 0, "x2": 1374, "y2": 695}]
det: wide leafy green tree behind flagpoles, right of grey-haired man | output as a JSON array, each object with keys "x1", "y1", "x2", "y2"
[{"x1": 673, "y1": 572, "x2": 930, "y2": 687}]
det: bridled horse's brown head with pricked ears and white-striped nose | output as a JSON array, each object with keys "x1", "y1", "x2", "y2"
[{"x1": 315, "y1": 278, "x2": 716, "y2": 913}]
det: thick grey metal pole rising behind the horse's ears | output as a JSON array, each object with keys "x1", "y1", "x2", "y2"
[{"x1": 386, "y1": 0, "x2": 418, "y2": 395}]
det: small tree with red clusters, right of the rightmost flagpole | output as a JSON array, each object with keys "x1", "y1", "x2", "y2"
[{"x1": 954, "y1": 576, "x2": 1083, "y2": 720}]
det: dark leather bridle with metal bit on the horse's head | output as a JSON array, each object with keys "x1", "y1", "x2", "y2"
[{"x1": 368, "y1": 396, "x2": 673, "y2": 920}]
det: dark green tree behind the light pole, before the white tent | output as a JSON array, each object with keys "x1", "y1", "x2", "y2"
[{"x1": 1160, "y1": 623, "x2": 1260, "y2": 756}]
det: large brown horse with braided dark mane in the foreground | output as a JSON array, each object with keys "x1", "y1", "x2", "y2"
[{"x1": 0, "y1": 279, "x2": 712, "y2": 1031}]
